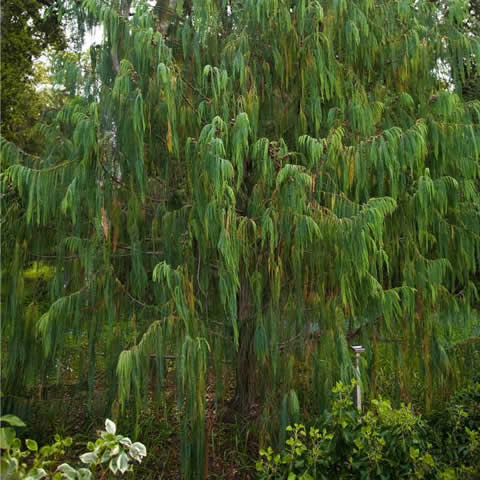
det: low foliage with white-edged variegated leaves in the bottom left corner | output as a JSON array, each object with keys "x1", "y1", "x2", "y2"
[{"x1": 0, "y1": 415, "x2": 147, "y2": 480}]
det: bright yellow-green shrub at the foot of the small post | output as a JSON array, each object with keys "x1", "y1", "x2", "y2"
[{"x1": 257, "y1": 383, "x2": 435, "y2": 480}]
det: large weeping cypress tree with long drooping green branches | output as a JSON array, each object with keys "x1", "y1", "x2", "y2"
[{"x1": 2, "y1": 0, "x2": 480, "y2": 478}]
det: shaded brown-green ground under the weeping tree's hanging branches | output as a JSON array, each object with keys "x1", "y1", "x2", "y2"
[{"x1": 6, "y1": 368, "x2": 258, "y2": 480}]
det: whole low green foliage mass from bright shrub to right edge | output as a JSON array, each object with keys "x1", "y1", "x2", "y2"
[{"x1": 256, "y1": 382, "x2": 480, "y2": 480}]
